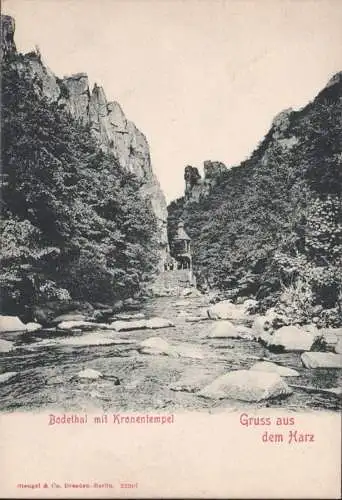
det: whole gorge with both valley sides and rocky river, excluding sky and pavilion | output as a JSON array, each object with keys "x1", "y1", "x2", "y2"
[{"x1": 0, "y1": 16, "x2": 342, "y2": 411}]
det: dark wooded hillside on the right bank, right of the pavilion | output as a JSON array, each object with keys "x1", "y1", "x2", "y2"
[{"x1": 168, "y1": 73, "x2": 342, "y2": 325}]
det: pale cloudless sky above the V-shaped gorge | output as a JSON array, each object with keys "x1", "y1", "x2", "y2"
[{"x1": 2, "y1": 0, "x2": 342, "y2": 201}]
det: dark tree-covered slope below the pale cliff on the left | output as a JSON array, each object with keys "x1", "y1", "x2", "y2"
[{"x1": 0, "y1": 51, "x2": 158, "y2": 315}]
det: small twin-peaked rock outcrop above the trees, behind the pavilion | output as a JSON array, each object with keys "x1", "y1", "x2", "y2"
[{"x1": 184, "y1": 160, "x2": 227, "y2": 202}]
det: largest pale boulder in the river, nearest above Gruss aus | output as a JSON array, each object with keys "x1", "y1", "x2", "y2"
[{"x1": 198, "y1": 370, "x2": 292, "y2": 402}]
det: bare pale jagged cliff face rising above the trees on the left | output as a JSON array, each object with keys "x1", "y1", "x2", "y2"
[{"x1": 1, "y1": 16, "x2": 168, "y2": 265}]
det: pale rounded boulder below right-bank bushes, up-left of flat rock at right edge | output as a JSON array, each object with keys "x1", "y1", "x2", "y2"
[{"x1": 260, "y1": 326, "x2": 315, "y2": 352}]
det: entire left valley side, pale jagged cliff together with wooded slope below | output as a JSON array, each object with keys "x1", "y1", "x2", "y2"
[{"x1": 0, "y1": 17, "x2": 168, "y2": 316}]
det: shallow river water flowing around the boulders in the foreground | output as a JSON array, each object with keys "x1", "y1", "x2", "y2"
[{"x1": 0, "y1": 297, "x2": 341, "y2": 412}]
